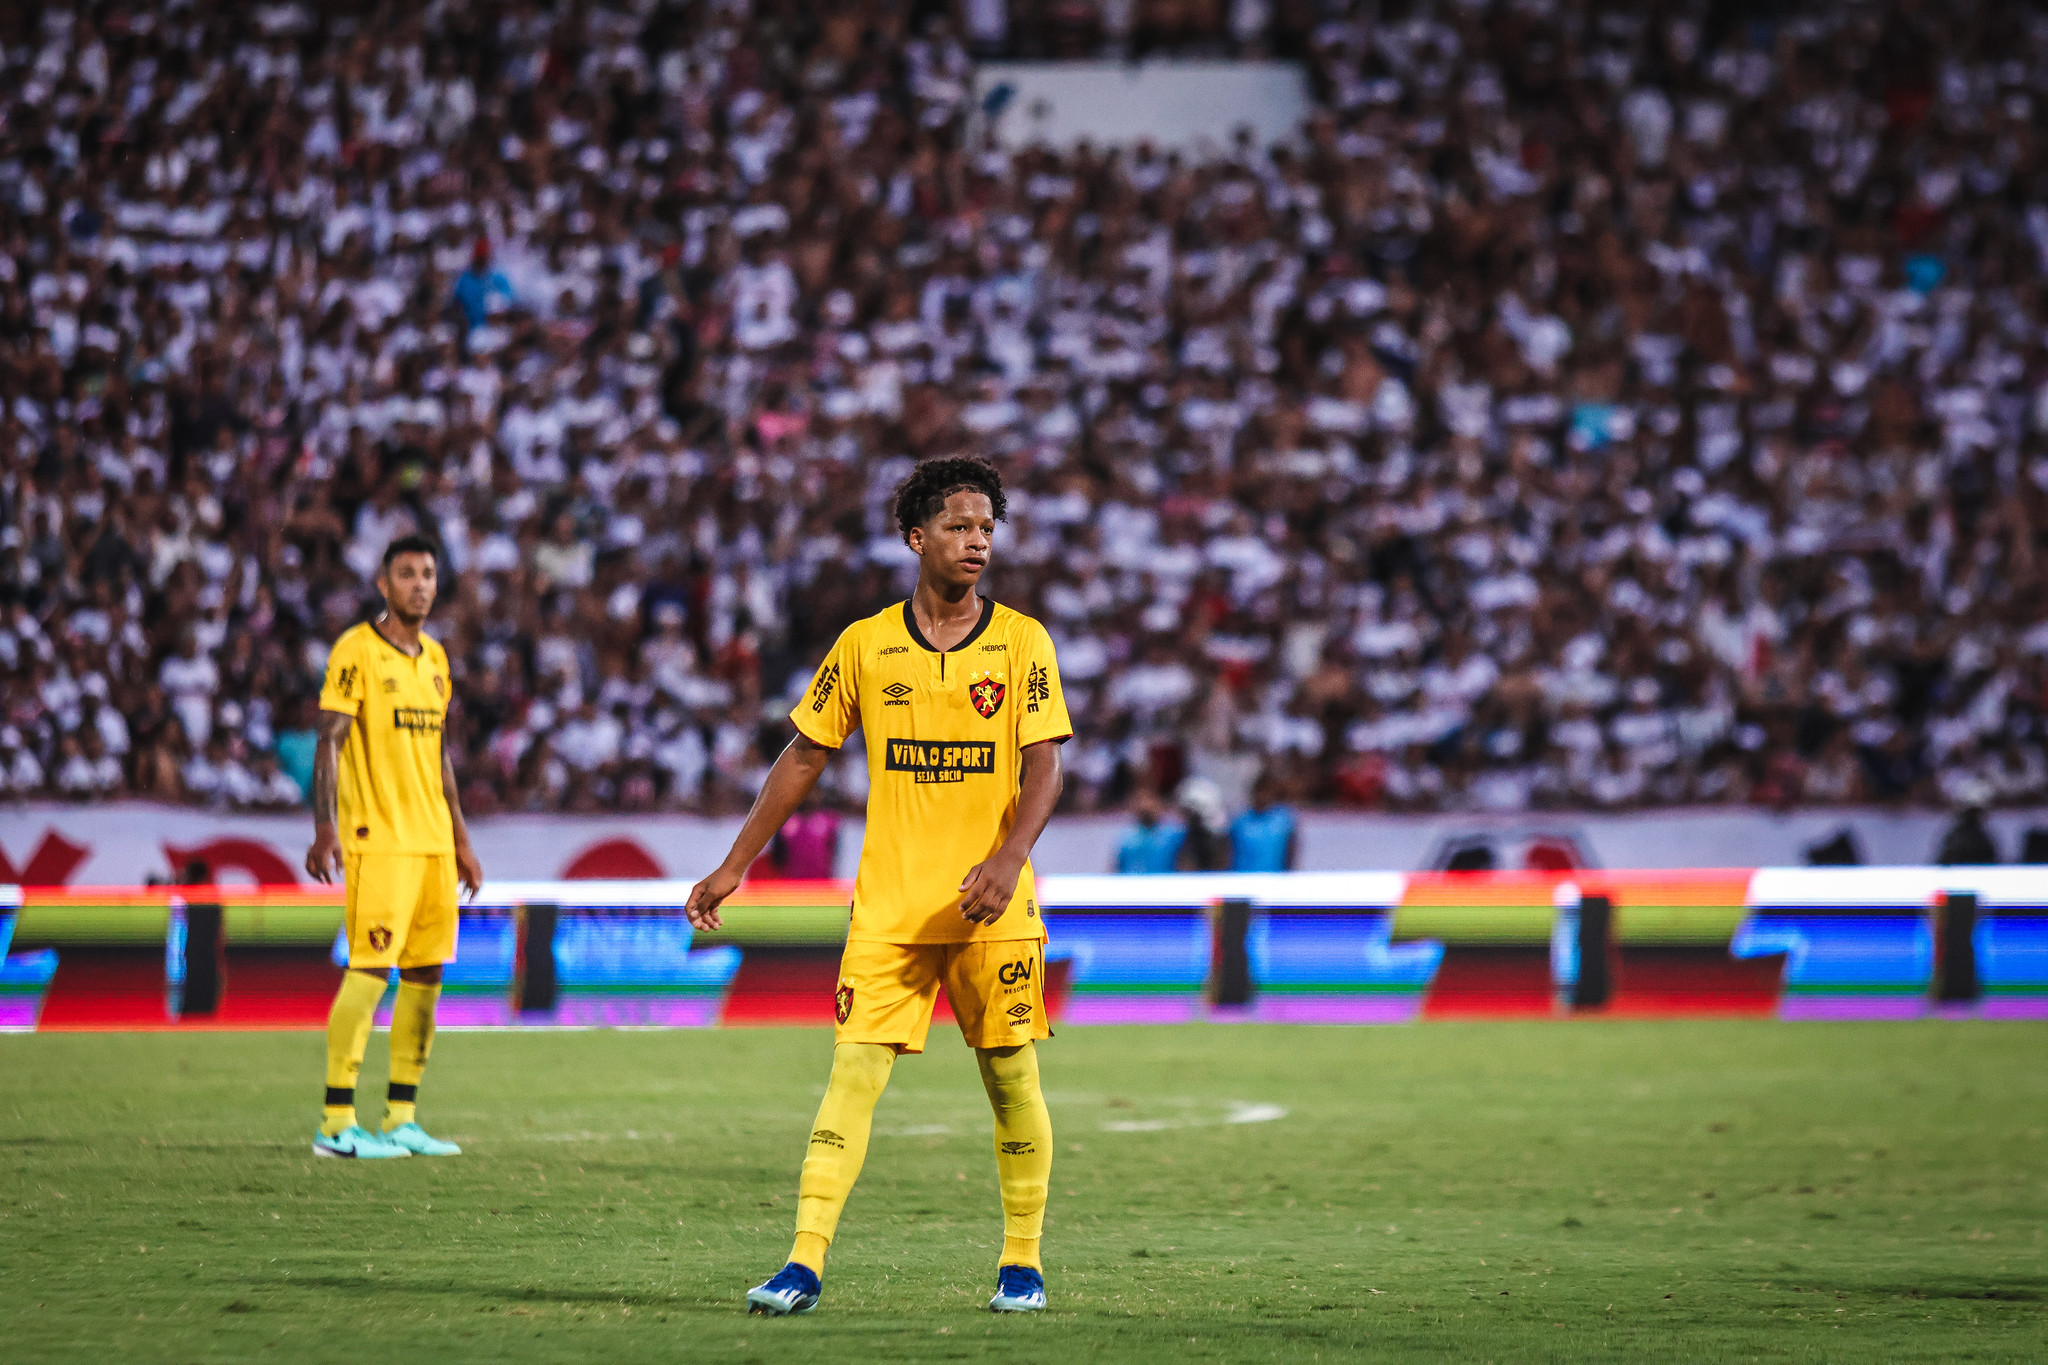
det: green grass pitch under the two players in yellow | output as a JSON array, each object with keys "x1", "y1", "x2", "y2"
[{"x1": 0, "y1": 1023, "x2": 2048, "y2": 1365}]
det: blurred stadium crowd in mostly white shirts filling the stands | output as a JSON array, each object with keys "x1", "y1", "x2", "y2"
[{"x1": 0, "y1": 0, "x2": 2048, "y2": 812}]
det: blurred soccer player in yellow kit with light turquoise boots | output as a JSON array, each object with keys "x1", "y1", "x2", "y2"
[{"x1": 305, "y1": 536, "x2": 483, "y2": 1156}]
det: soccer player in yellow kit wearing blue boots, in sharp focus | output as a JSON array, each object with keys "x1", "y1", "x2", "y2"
[{"x1": 688, "y1": 458, "x2": 1073, "y2": 1316}]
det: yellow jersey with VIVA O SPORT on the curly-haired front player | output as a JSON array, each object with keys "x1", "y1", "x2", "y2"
[{"x1": 791, "y1": 598, "x2": 1073, "y2": 943}]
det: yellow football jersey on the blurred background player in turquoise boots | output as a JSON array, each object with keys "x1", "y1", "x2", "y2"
[{"x1": 319, "y1": 622, "x2": 455, "y2": 853}]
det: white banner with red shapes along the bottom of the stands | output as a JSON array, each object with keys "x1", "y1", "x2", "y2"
[{"x1": 0, "y1": 802, "x2": 2048, "y2": 886}]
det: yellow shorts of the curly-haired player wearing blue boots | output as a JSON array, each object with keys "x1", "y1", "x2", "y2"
[{"x1": 834, "y1": 939, "x2": 1053, "y2": 1052}]
